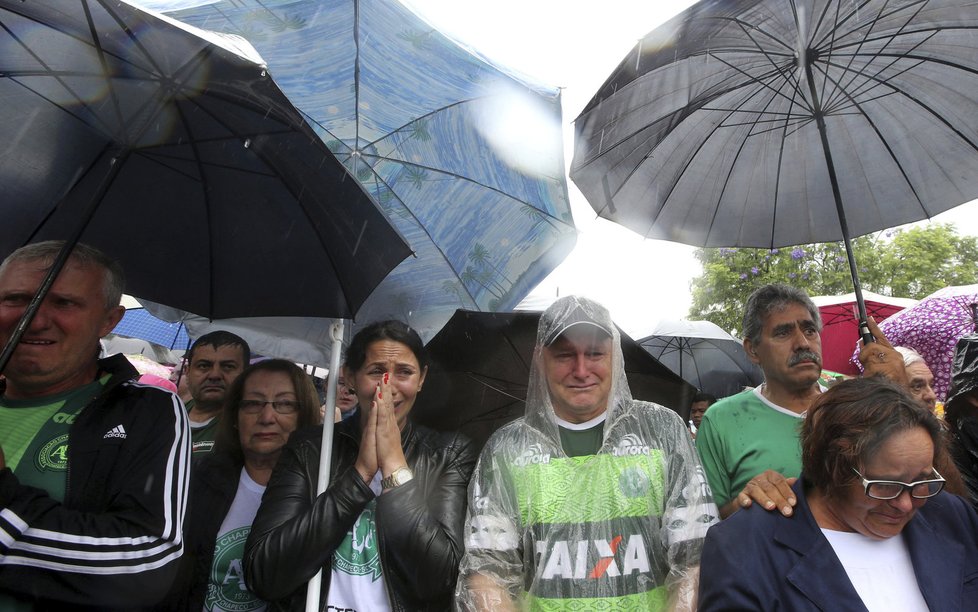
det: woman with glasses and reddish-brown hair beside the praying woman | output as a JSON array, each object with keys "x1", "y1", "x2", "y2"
[{"x1": 161, "y1": 359, "x2": 319, "y2": 612}]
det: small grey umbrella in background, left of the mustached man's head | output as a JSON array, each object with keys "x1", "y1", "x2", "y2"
[{"x1": 637, "y1": 319, "x2": 764, "y2": 398}]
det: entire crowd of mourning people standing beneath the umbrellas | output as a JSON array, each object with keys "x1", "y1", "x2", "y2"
[{"x1": 0, "y1": 242, "x2": 978, "y2": 612}]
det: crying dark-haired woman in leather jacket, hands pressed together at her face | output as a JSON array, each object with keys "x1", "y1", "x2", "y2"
[{"x1": 245, "y1": 321, "x2": 476, "y2": 612}]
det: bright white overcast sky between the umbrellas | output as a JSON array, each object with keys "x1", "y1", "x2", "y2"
[{"x1": 403, "y1": 0, "x2": 978, "y2": 336}]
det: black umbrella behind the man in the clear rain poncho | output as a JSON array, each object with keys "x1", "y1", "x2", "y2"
[{"x1": 412, "y1": 310, "x2": 696, "y2": 446}]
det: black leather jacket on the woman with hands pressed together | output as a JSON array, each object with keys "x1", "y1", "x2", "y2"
[{"x1": 244, "y1": 418, "x2": 476, "y2": 610}]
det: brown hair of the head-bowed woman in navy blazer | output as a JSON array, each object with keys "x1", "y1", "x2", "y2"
[{"x1": 801, "y1": 376, "x2": 943, "y2": 497}]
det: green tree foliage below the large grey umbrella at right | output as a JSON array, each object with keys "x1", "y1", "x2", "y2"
[{"x1": 689, "y1": 224, "x2": 978, "y2": 331}]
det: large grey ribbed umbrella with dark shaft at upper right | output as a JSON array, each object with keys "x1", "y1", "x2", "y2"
[{"x1": 571, "y1": 0, "x2": 978, "y2": 338}]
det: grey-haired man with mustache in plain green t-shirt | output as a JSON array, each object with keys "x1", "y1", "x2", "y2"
[{"x1": 696, "y1": 284, "x2": 822, "y2": 518}]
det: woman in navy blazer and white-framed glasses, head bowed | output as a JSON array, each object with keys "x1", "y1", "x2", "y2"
[{"x1": 699, "y1": 377, "x2": 978, "y2": 612}]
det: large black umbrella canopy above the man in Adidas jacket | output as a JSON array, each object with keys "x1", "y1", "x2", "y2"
[{"x1": 0, "y1": 0, "x2": 410, "y2": 318}]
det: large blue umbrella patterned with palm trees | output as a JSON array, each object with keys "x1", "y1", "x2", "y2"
[{"x1": 143, "y1": 0, "x2": 576, "y2": 338}]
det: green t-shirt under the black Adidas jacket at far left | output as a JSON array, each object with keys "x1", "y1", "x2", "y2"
[{"x1": 0, "y1": 375, "x2": 109, "y2": 502}]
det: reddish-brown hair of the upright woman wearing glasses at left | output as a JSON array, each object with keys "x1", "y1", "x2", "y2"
[{"x1": 214, "y1": 359, "x2": 319, "y2": 464}]
